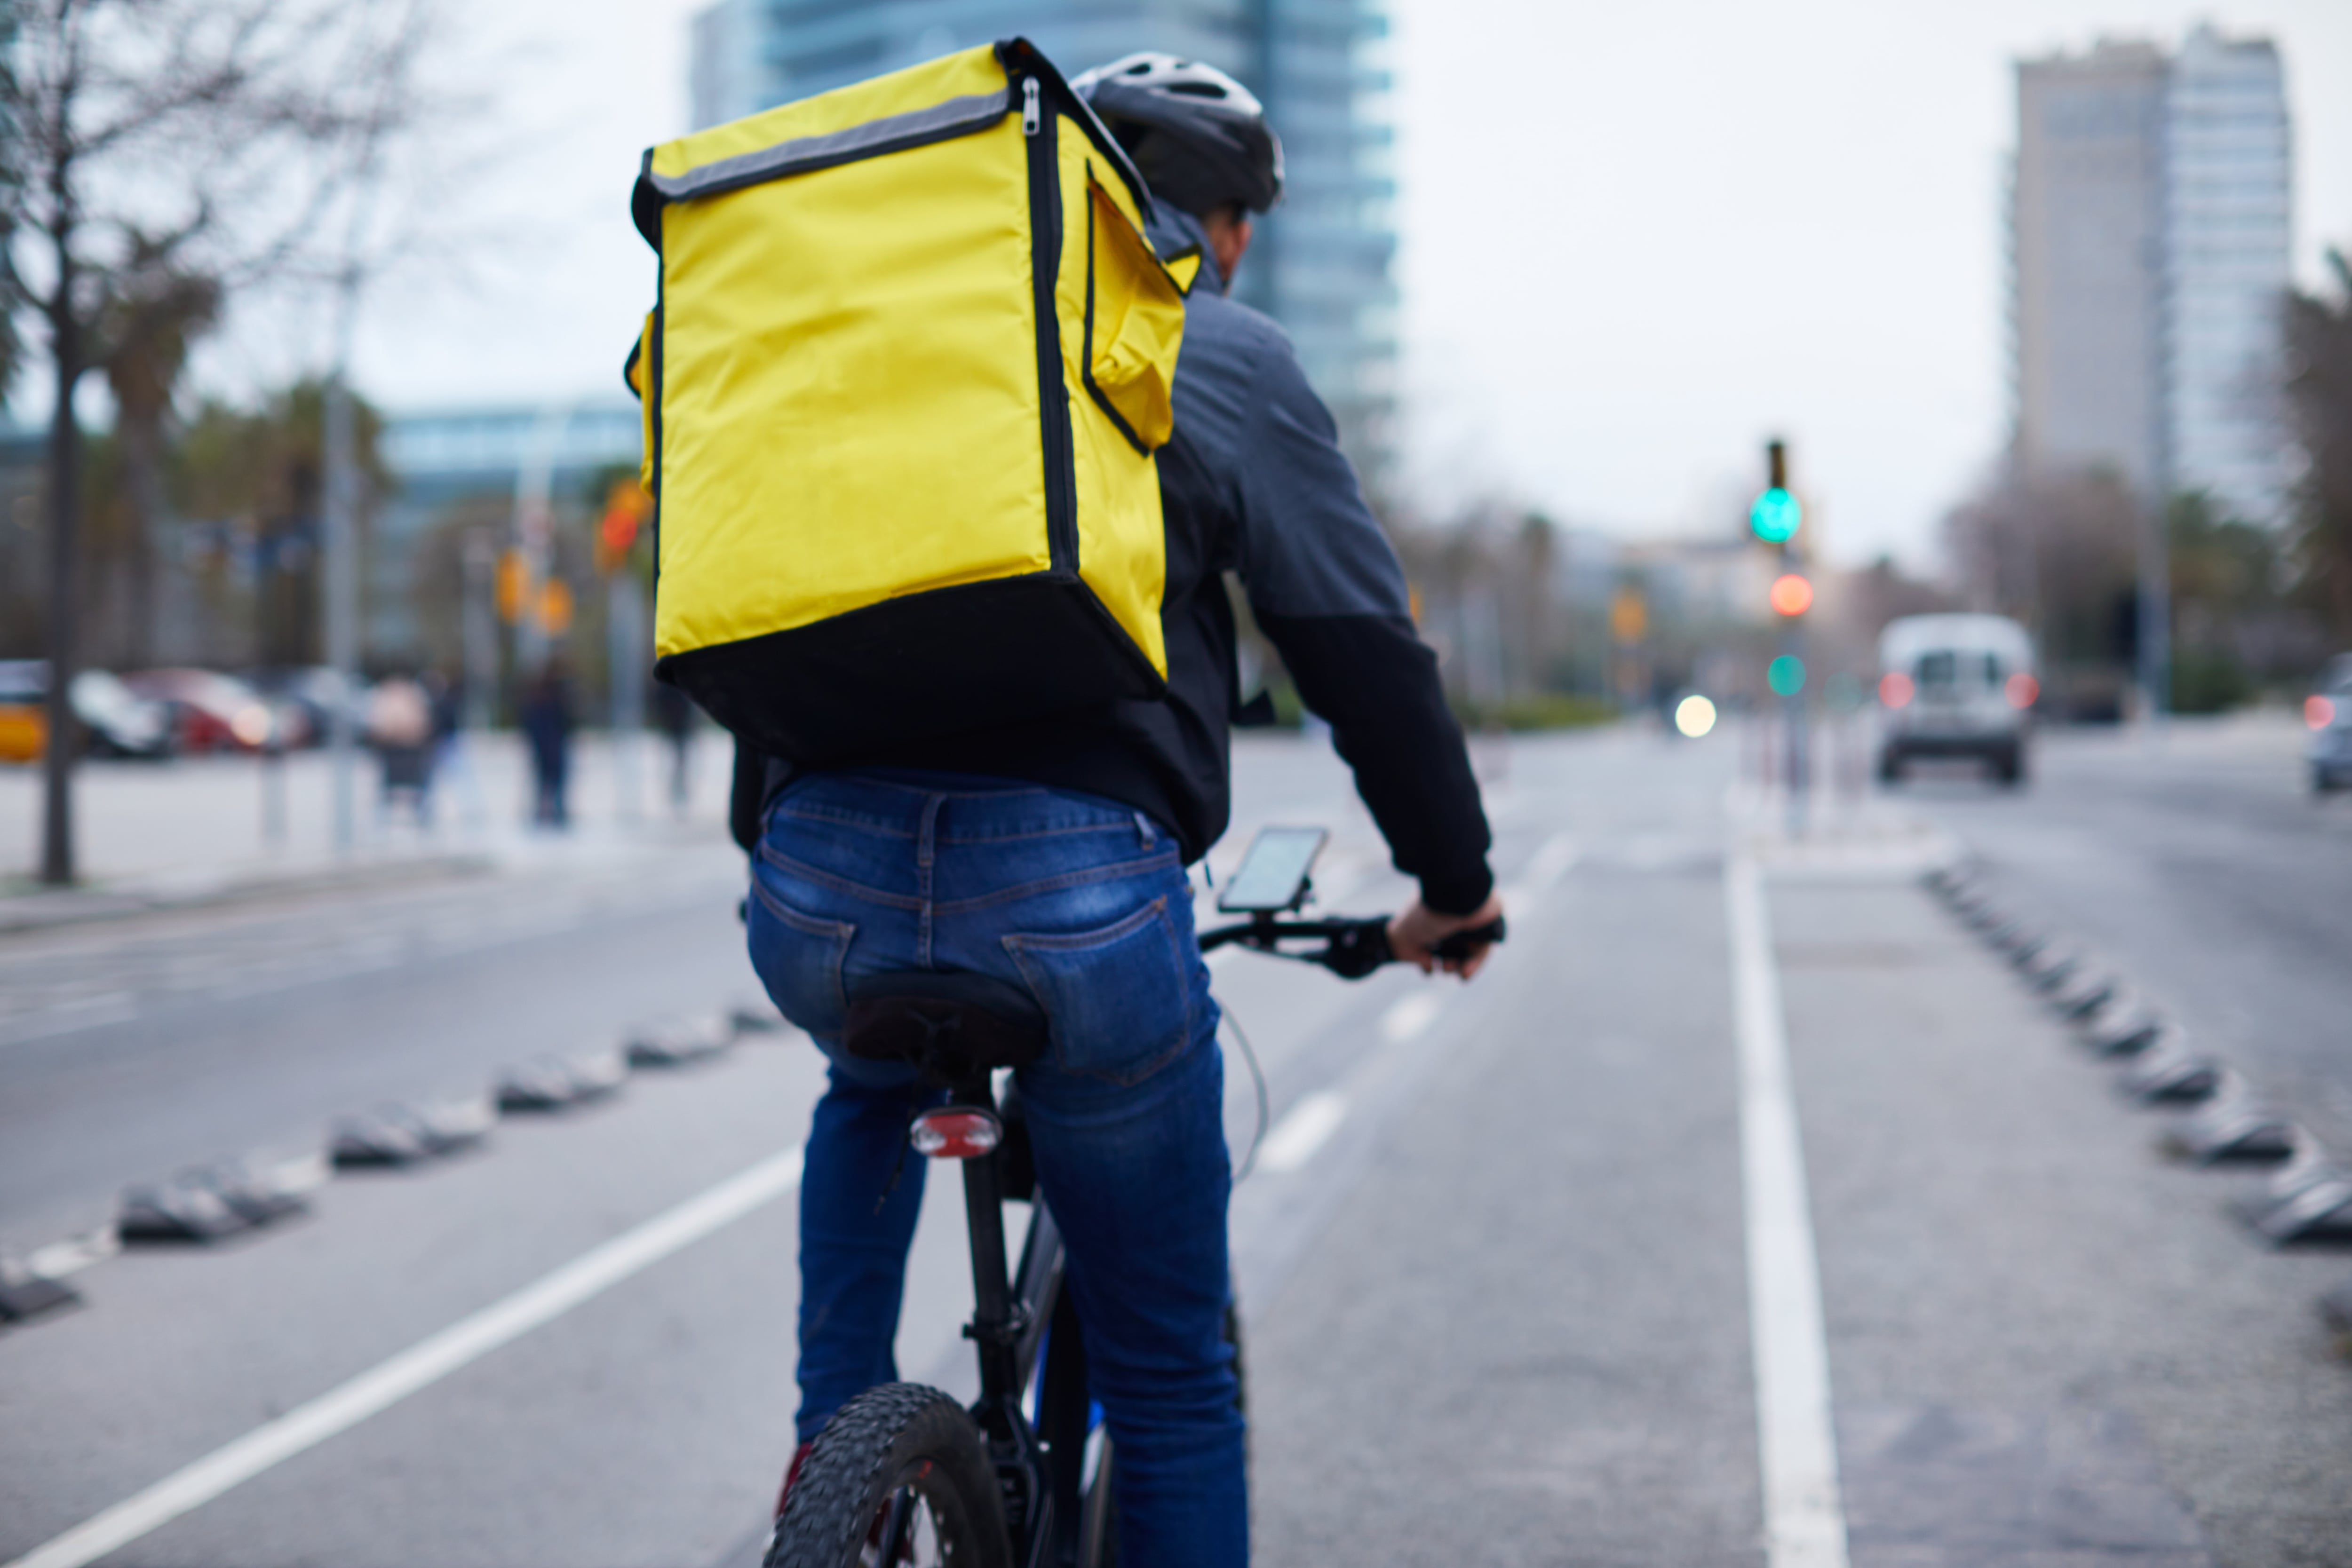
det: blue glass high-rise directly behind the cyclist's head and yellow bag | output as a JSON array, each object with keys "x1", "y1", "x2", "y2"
[{"x1": 694, "y1": 0, "x2": 1397, "y2": 482}]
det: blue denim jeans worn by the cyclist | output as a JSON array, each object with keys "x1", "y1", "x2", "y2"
[{"x1": 748, "y1": 771, "x2": 1249, "y2": 1568}]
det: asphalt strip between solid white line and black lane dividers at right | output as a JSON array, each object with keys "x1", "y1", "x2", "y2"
[{"x1": 1771, "y1": 870, "x2": 2352, "y2": 1568}]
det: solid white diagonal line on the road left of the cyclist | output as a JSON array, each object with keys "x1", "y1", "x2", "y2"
[{"x1": 5, "y1": 1147, "x2": 800, "y2": 1568}]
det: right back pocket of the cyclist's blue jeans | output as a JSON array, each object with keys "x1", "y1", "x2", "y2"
[{"x1": 1002, "y1": 895, "x2": 1192, "y2": 1084}]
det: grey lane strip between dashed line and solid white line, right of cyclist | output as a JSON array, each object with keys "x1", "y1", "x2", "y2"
[{"x1": 1244, "y1": 832, "x2": 1759, "y2": 1568}]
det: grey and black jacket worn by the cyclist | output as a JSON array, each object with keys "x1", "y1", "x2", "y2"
[{"x1": 734, "y1": 209, "x2": 1494, "y2": 914}]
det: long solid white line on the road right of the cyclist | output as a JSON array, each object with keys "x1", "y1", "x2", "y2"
[{"x1": 1724, "y1": 855, "x2": 1846, "y2": 1568}]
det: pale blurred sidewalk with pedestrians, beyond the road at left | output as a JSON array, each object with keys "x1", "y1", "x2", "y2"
[{"x1": 0, "y1": 729, "x2": 729, "y2": 933}]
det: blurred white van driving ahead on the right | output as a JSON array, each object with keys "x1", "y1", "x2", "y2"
[{"x1": 1879, "y1": 616, "x2": 2042, "y2": 783}]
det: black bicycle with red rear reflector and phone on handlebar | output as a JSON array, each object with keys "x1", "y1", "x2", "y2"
[{"x1": 762, "y1": 827, "x2": 1503, "y2": 1568}]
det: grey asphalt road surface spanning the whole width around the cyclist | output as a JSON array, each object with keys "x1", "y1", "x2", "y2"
[{"x1": 0, "y1": 734, "x2": 2352, "y2": 1568}]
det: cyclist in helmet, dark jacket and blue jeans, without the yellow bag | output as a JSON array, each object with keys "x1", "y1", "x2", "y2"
[{"x1": 734, "y1": 54, "x2": 1501, "y2": 1568}]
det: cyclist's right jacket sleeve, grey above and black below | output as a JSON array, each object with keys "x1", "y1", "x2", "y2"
[{"x1": 1235, "y1": 350, "x2": 1494, "y2": 914}]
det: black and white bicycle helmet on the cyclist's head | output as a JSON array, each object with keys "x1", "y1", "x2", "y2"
[{"x1": 1070, "y1": 54, "x2": 1282, "y2": 216}]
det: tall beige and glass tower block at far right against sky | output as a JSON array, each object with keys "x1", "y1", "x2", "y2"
[{"x1": 2009, "y1": 26, "x2": 2293, "y2": 522}]
